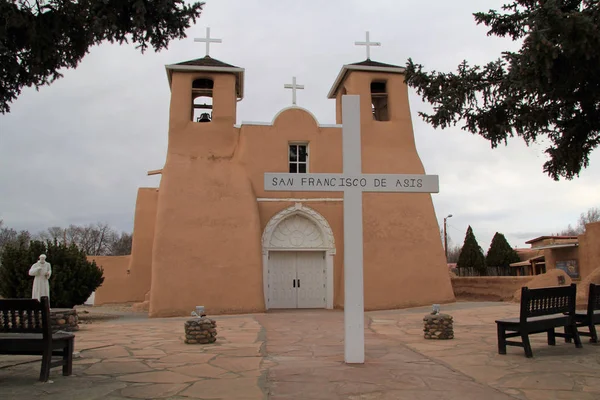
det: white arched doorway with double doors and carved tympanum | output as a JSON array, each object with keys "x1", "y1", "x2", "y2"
[{"x1": 262, "y1": 203, "x2": 335, "y2": 309}]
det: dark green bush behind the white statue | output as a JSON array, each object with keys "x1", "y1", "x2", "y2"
[{"x1": 0, "y1": 241, "x2": 104, "y2": 308}]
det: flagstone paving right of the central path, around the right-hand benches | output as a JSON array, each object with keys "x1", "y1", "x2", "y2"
[{"x1": 370, "y1": 303, "x2": 600, "y2": 400}]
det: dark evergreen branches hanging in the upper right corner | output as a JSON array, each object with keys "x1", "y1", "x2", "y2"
[{"x1": 406, "y1": 0, "x2": 600, "y2": 180}]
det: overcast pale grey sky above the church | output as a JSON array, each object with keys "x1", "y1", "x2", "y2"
[{"x1": 0, "y1": 0, "x2": 600, "y2": 251}]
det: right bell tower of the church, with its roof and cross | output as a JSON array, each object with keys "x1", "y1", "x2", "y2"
[{"x1": 328, "y1": 32, "x2": 454, "y2": 309}]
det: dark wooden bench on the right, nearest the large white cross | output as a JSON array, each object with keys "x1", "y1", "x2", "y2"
[{"x1": 496, "y1": 283, "x2": 582, "y2": 357}]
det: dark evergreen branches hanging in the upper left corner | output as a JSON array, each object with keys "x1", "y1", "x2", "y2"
[{"x1": 0, "y1": 0, "x2": 204, "y2": 113}]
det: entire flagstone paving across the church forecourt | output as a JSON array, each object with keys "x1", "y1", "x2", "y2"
[{"x1": 0, "y1": 303, "x2": 600, "y2": 400}]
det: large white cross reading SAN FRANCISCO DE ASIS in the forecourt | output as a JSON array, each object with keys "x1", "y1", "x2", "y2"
[{"x1": 264, "y1": 95, "x2": 439, "y2": 364}]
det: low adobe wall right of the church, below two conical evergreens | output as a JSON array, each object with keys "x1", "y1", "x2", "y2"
[{"x1": 452, "y1": 276, "x2": 533, "y2": 301}]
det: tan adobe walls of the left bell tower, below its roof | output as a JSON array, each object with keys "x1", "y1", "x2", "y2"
[{"x1": 149, "y1": 73, "x2": 265, "y2": 317}]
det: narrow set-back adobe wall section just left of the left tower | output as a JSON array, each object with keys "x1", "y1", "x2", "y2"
[{"x1": 129, "y1": 188, "x2": 158, "y2": 301}]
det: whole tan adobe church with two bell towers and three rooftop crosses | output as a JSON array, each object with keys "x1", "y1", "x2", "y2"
[{"x1": 97, "y1": 30, "x2": 454, "y2": 317}]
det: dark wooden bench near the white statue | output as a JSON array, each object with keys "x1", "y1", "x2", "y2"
[{"x1": 0, "y1": 297, "x2": 75, "y2": 382}]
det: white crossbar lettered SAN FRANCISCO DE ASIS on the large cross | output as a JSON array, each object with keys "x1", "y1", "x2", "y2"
[{"x1": 265, "y1": 173, "x2": 439, "y2": 193}]
